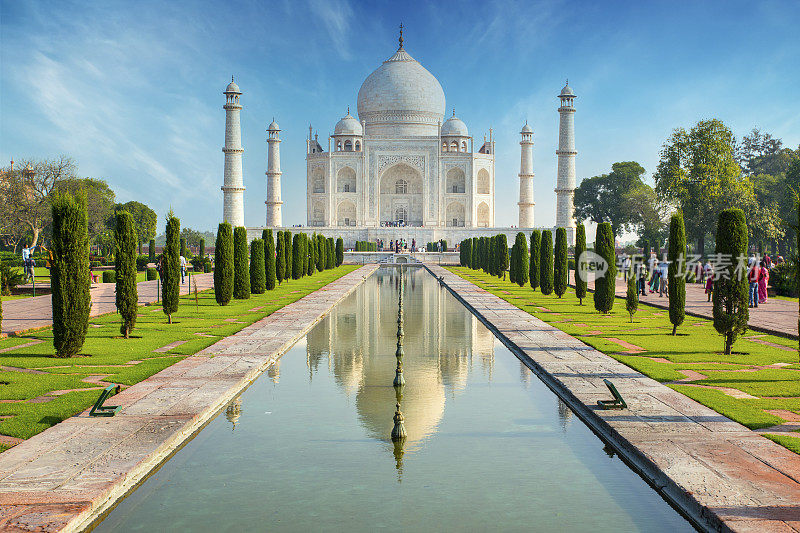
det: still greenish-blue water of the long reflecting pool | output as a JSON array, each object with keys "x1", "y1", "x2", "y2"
[{"x1": 97, "y1": 268, "x2": 693, "y2": 532}]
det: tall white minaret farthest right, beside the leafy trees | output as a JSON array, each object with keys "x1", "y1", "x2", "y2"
[{"x1": 556, "y1": 80, "x2": 578, "y2": 232}]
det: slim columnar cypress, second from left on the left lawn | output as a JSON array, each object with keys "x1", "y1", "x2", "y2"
[{"x1": 114, "y1": 211, "x2": 139, "y2": 339}]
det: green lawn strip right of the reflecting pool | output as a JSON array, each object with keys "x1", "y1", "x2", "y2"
[{"x1": 448, "y1": 267, "x2": 800, "y2": 451}]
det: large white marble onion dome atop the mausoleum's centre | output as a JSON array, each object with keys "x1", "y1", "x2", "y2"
[{"x1": 358, "y1": 45, "x2": 445, "y2": 135}]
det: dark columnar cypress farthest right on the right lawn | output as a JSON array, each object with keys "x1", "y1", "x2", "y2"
[{"x1": 712, "y1": 209, "x2": 750, "y2": 355}]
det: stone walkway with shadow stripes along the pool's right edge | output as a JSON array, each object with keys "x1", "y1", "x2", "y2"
[{"x1": 428, "y1": 265, "x2": 800, "y2": 532}]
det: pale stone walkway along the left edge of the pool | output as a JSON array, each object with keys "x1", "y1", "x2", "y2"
[{"x1": 0, "y1": 265, "x2": 377, "y2": 531}]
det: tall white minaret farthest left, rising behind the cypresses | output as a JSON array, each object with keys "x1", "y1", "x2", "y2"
[{"x1": 222, "y1": 76, "x2": 244, "y2": 227}]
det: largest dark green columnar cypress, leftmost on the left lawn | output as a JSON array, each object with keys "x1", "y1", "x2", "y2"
[{"x1": 50, "y1": 192, "x2": 91, "y2": 357}]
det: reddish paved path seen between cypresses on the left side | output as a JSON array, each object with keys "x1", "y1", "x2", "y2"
[{"x1": 2, "y1": 273, "x2": 214, "y2": 335}]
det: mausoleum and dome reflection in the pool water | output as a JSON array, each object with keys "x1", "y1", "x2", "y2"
[{"x1": 307, "y1": 267, "x2": 495, "y2": 458}]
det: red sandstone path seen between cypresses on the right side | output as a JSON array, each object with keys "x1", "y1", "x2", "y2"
[{"x1": 570, "y1": 270, "x2": 797, "y2": 338}]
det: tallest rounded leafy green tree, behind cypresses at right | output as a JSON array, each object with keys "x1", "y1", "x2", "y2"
[{"x1": 653, "y1": 119, "x2": 755, "y2": 254}]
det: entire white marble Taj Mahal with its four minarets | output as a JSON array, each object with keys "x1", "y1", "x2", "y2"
[{"x1": 222, "y1": 28, "x2": 577, "y2": 247}]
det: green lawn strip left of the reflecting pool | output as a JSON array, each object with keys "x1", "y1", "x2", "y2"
[{"x1": 0, "y1": 265, "x2": 358, "y2": 439}]
